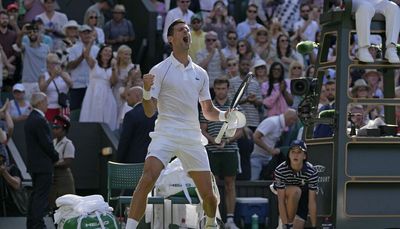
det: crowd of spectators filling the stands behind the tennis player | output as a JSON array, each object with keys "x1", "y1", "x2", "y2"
[{"x1": 0, "y1": 0, "x2": 400, "y2": 223}]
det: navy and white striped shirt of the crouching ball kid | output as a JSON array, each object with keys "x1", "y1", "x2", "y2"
[{"x1": 274, "y1": 161, "x2": 318, "y2": 191}]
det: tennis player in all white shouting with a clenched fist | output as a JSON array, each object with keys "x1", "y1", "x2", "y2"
[{"x1": 126, "y1": 19, "x2": 228, "y2": 229}]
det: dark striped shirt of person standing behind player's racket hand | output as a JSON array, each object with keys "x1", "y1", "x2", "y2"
[{"x1": 200, "y1": 99, "x2": 241, "y2": 153}]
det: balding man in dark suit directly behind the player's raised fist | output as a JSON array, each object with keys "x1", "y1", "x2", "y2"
[{"x1": 117, "y1": 86, "x2": 157, "y2": 163}]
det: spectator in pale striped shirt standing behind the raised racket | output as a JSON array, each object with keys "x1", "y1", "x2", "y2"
[{"x1": 229, "y1": 58, "x2": 262, "y2": 131}]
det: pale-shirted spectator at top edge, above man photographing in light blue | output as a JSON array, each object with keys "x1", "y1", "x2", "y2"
[{"x1": 36, "y1": 0, "x2": 68, "y2": 50}]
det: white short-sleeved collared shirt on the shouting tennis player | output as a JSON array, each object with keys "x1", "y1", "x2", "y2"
[{"x1": 150, "y1": 53, "x2": 211, "y2": 140}]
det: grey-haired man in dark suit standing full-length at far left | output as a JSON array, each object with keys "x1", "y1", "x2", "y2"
[{"x1": 24, "y1": 92, "x2": 58, "y2": 229}]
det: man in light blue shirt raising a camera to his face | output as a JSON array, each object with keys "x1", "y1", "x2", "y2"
[{"x1": 17, "y1": 24, "x2": 50, "y2": 99}]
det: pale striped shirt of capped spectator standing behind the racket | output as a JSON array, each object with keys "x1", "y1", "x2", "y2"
[{"x1": 229, "y1": 76, "x2": 262, "y2": 127}]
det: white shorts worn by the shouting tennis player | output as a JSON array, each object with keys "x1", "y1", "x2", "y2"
[{"x1": 146, "y1": 132, "x2": 211, "y2": 172}]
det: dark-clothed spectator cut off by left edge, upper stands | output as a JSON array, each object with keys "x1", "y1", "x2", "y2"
[{"x1": 0, "y1": 11, "x2": 17, "y2": 75}]
